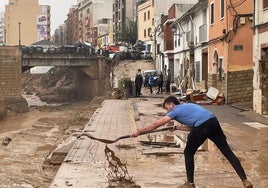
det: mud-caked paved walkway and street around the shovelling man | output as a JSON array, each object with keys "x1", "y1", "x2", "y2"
[{"x1": 50, "y1": 83, "x2": 268, "y2": 188}]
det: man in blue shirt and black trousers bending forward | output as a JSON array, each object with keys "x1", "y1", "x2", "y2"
[{"x1": 132, "y1": 96, "x2": 253, "y2": 188}]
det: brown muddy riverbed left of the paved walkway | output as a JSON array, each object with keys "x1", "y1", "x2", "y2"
[{"x1": 0, "y1": 95, "x2": 103, "y2": 188}]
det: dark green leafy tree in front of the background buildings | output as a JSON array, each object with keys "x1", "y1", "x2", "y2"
[{"x1": 117, "y1": 18, "x2": 138, "y2": 45}]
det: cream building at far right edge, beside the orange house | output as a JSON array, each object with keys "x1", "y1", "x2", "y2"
[{"x1": 252, "y1": 0, "x2": 268, "y2": 115}]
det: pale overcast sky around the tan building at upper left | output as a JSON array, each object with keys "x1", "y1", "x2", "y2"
[{"x1": 0, "y1": 0, "x2": 77, "y2": 34}]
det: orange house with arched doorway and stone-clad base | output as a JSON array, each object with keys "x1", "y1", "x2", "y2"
[{"x1": 208, "y1": 0, "x2": 253, "y2": 103}]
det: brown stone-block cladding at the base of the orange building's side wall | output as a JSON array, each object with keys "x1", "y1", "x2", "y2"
[{"x1": 227, "y1": 69, "x2": 253, "y2": 104}]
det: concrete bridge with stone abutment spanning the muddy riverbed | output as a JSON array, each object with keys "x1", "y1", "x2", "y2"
[{"x1": 0, "y1": 46, "x2": 111, "y2": 112}]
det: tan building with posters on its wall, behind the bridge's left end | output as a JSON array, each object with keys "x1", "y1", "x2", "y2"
[{"x1": 5, "y1": 0, "x2": 50, "y2": 45}]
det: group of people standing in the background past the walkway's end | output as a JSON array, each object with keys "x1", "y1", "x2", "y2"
[{"x1": 135, "y1": 69, "x2": 171, "y2": 97}]
